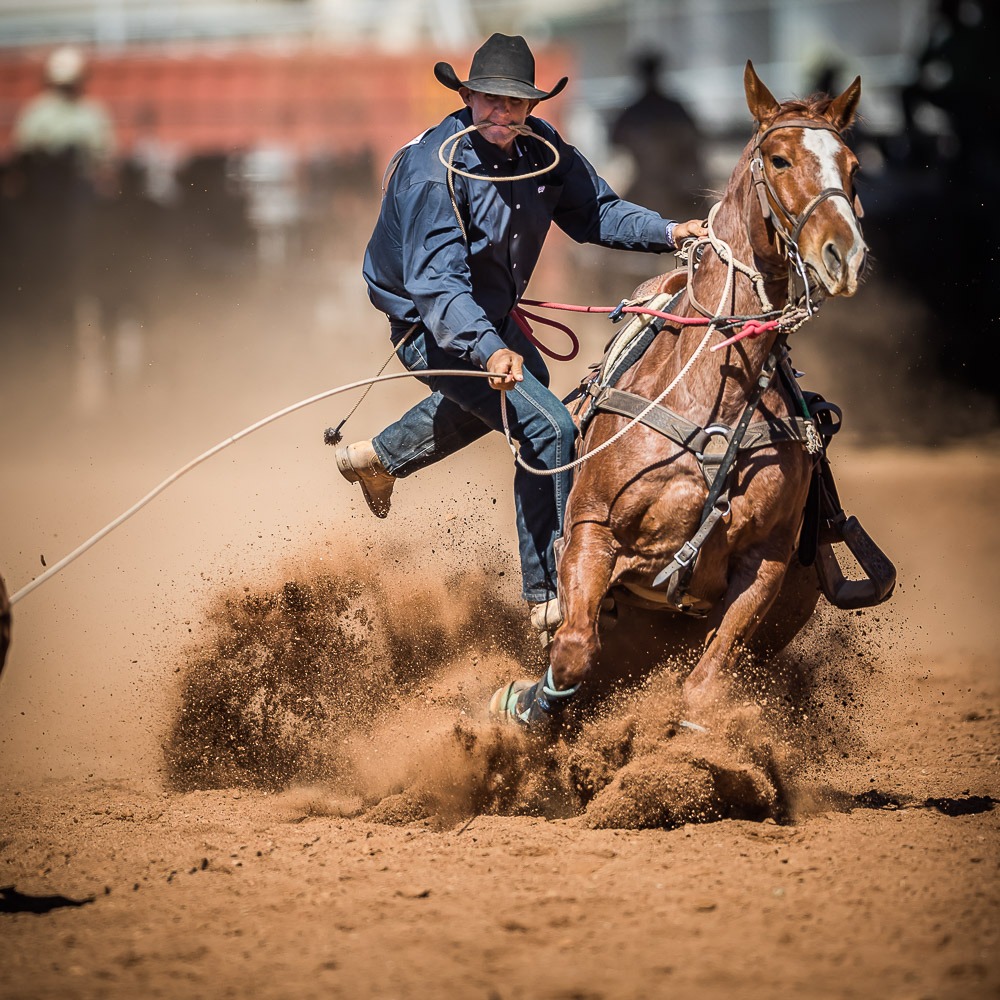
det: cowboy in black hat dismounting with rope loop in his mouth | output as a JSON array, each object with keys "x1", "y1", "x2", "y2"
[{"x1": 336, "y1": 34, "x2": 706, "y2": 632}]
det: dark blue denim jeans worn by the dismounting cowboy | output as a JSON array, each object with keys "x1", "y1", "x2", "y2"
[{"x1": 372, "y1": 319, "x2": 576, "y2": 603}]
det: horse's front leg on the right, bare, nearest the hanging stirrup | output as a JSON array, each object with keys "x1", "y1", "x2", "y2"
[{"x1": 684, "y1": 556, "x2": 788, "y2": 720}]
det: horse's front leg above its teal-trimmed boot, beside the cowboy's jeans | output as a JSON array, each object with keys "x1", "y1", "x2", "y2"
[{"x1": 549, "y1": 521, "x2": 615, "y2": 690}]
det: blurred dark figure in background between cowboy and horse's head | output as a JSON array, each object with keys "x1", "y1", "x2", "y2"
[{"x1": 609, "y1": 52, "x2": 708, "y2": 218}]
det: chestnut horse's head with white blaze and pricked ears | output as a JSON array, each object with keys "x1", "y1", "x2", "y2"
[{"x1": 743, "y1": 62, "x2": 867, "y2": 295}]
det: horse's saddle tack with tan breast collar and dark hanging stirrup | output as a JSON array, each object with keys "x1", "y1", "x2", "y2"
[{"x1": 565, "y1": 278, "x2": 896, "y2": 616}]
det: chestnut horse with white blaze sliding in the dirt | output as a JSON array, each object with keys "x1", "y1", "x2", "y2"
[{"x1": 491, "y1": 62, "x2": 867, "y2": 725}]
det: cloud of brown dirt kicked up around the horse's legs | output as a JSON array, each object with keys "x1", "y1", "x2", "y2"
[{"x1": 164, "y1": 528, "x2": 892, "y2": 828}]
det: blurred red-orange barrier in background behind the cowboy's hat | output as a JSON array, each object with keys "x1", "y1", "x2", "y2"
[{"x1": 0, "y1": 49, "x2": 570, "y2": 170}]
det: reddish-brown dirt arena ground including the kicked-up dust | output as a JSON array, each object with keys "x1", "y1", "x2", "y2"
[{"x1": 0, "y1": 236, "x2": 1000, "y2": 1000}]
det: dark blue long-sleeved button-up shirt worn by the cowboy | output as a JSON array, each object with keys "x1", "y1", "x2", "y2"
[{"x1": 364, "y1": 108, "x2": 673, "y2": 367}]
